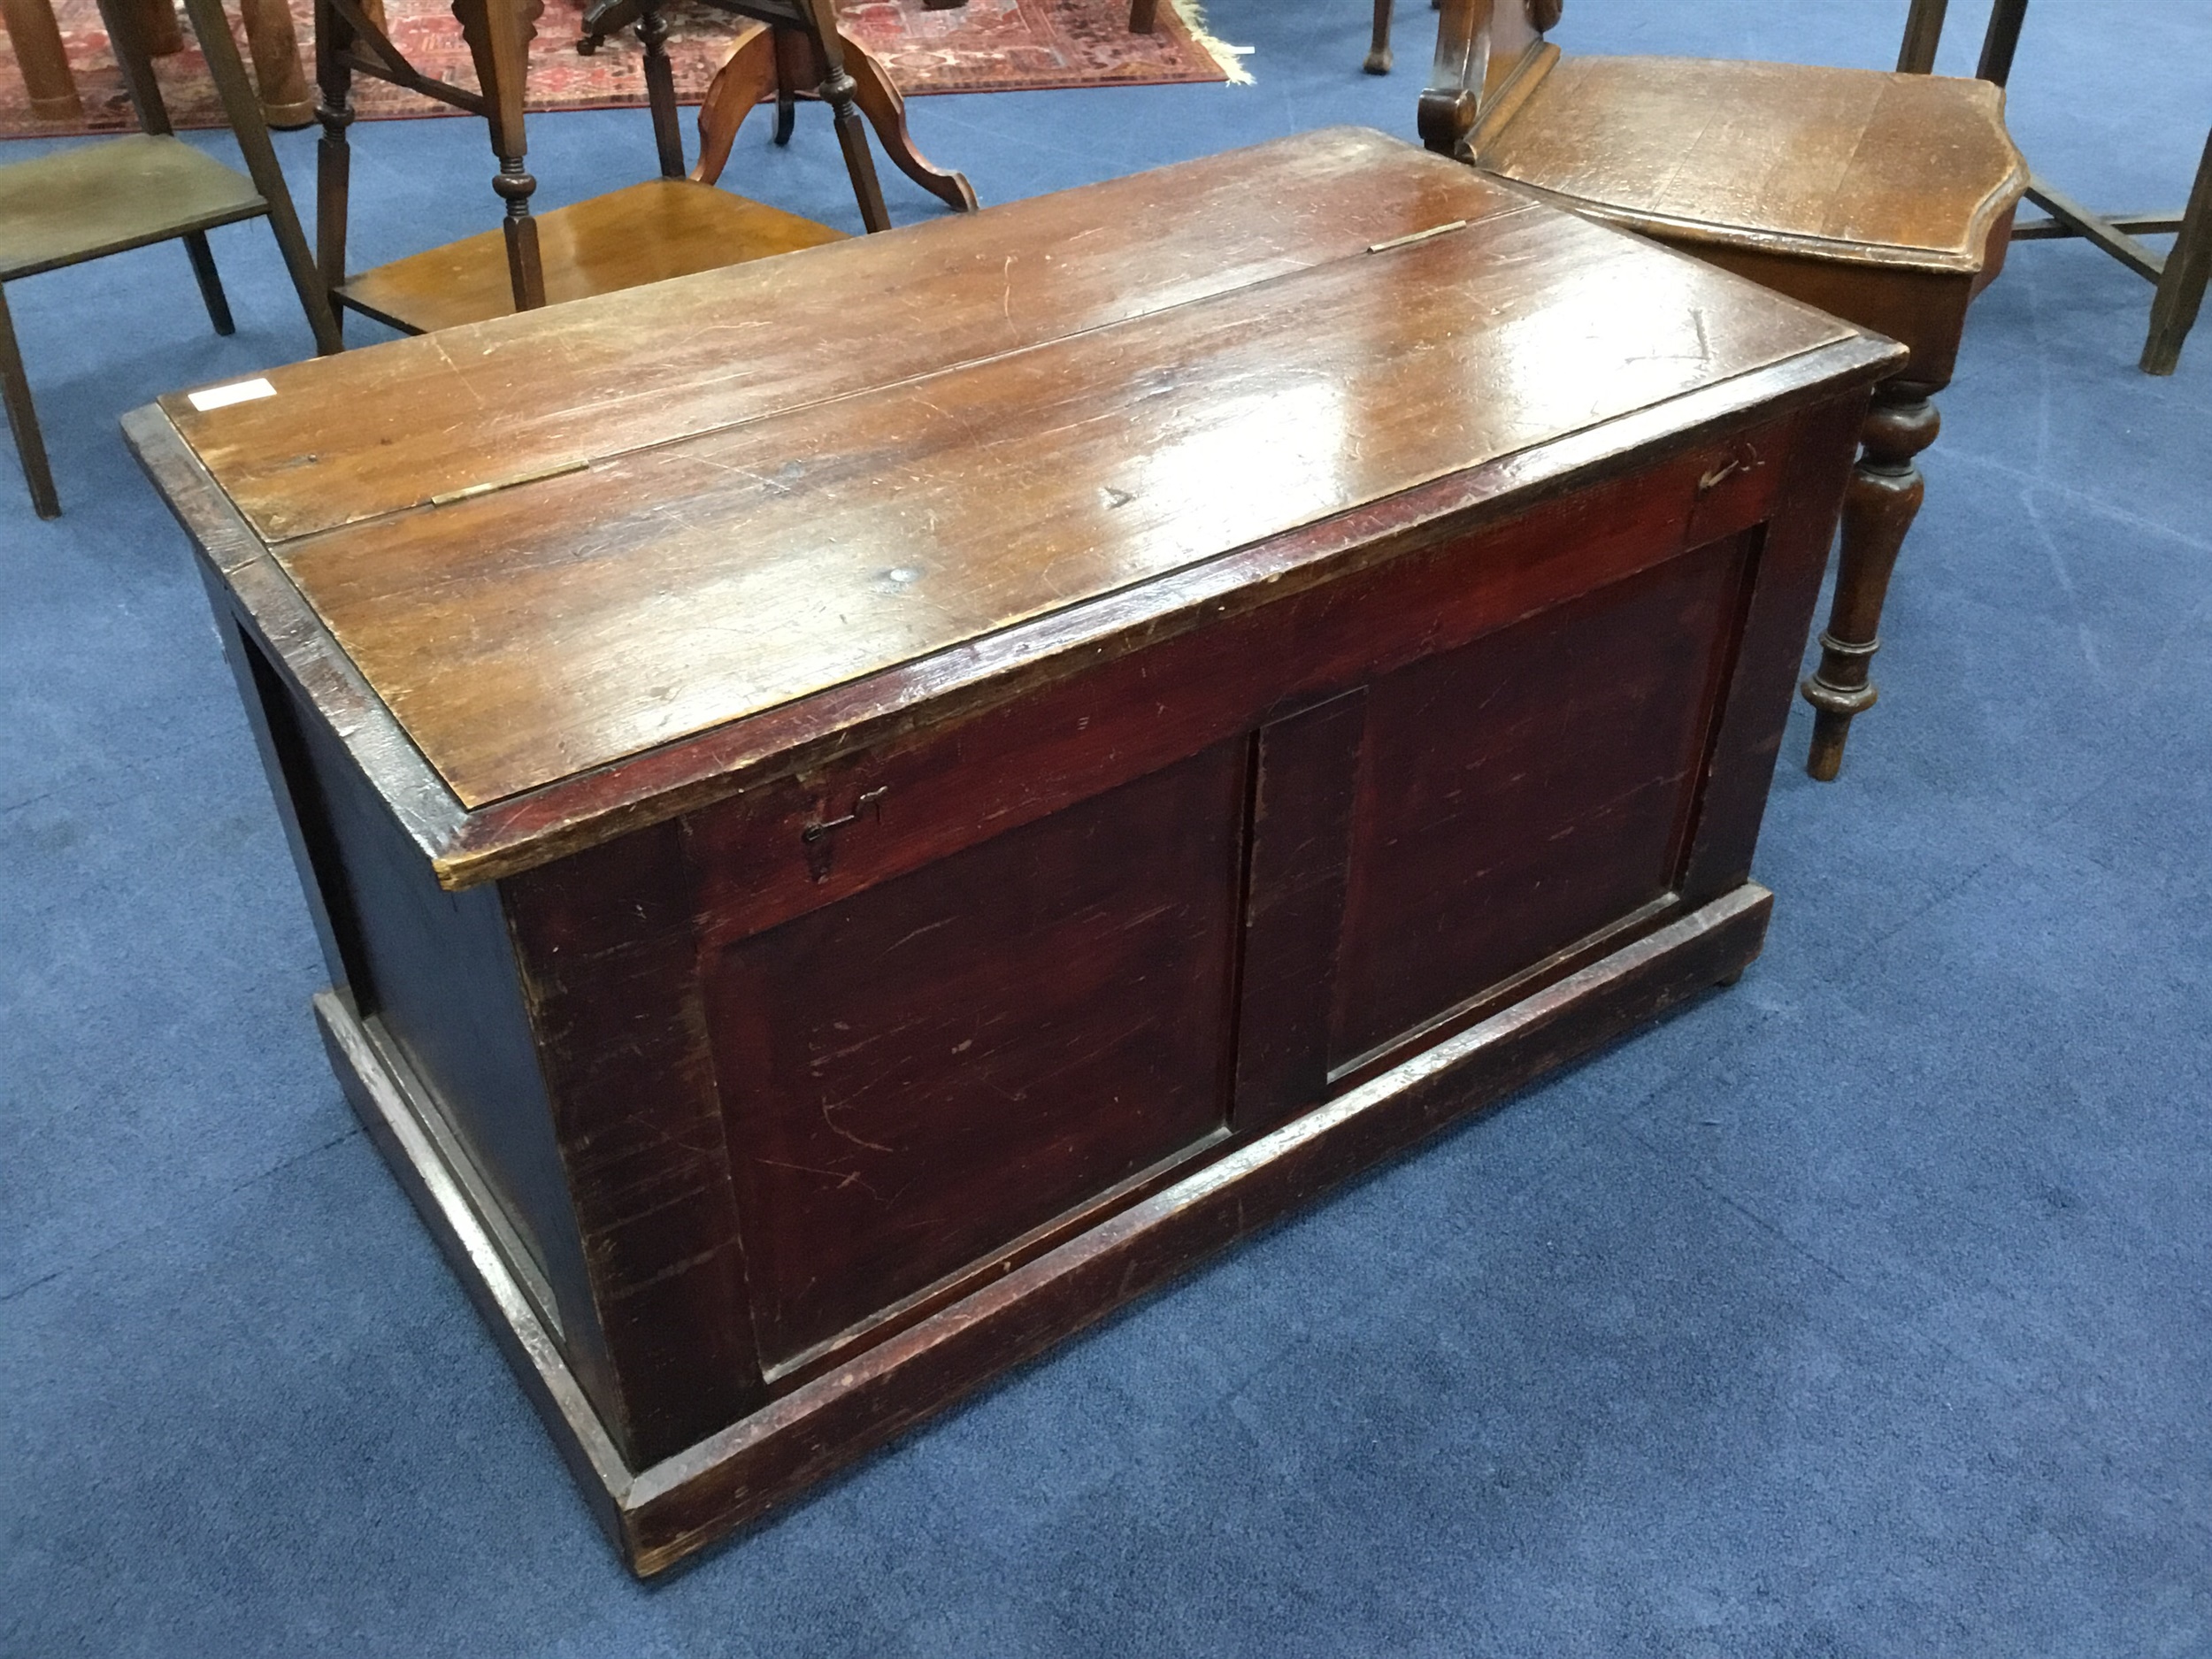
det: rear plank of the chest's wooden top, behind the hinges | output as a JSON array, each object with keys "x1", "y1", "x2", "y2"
[{"x1": 162, "y1": 128, "x2": 1529, "y2": 540}]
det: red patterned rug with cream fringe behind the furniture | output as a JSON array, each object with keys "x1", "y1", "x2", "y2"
[{"x1": 0, "y1": 0, "x2": 1230, "y2": 137}]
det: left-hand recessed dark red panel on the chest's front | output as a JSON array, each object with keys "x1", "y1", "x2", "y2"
[{"x1": 706, "y1": 743, "x2": 1246, "y2": 1367}]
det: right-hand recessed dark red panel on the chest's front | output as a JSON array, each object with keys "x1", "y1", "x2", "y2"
[{"x1": 1332, "y1": 526, "x2": 1741, "y2": 1064}]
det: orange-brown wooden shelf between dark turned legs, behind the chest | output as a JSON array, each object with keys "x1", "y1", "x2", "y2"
[{"x1": 339, "y1": 180, "x2": 845, "y2": 334}]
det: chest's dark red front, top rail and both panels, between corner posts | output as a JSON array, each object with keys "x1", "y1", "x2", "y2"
[{"x1": 646, "y1": 438, "x2": 1772, "y2": 1387}]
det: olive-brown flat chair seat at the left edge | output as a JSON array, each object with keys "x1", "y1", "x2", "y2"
[{"x1": 0, "y1": 133, "x2": 268, "y2": 281}]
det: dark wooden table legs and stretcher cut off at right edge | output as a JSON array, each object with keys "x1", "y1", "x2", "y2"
[{"x1": 1898, "y1": 0, "x2": 2212, "y2": 374}]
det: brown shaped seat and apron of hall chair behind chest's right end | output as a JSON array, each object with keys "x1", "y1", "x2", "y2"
[{"x1": 1476, "y1": 58, "x2": 2029, "y2": 388}]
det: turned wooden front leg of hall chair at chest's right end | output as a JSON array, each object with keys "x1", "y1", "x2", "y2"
[{"x1": 1803, "y1": 380, "x2": 1942, "y2": 783}]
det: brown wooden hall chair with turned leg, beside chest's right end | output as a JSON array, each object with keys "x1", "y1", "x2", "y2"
[{"x1": 1420, "y1": 0, "x2": 2029, "y2": 781}]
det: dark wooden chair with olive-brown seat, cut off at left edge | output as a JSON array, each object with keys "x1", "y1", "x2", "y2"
[{"x1": 0, "y1": 0, "x2": 339, "y2": 518}]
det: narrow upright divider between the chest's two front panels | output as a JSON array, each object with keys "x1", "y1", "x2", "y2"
[{"x1": 1234, "y1": 686, "x2": 1367, "y2": 1135}]
